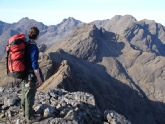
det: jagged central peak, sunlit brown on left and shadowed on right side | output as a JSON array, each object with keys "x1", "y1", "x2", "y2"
[{"x1": 47, "y1": 23, "x2": 116, "y2": 62}]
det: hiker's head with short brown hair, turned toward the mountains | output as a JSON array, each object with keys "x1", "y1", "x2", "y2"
[{"x1": 28, "y1": 26, "x2": 40, "y2": 40}]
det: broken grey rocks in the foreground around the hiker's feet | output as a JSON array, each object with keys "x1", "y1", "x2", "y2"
[{"x1": 0, "y1": 87, "x2": 131, "y2": 124}]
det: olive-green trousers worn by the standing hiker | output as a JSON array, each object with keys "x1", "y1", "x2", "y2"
[{"x1": 21, "y1": 74, "x2": 37, "y2": 119}]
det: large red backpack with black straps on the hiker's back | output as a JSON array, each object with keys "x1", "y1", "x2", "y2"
[{"x1": 6, "y1": 33, "x2": 26, "y2": 79}]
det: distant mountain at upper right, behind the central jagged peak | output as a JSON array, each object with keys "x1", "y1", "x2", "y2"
[{"x1": 93, "y1": 15, "x2": 165, "y2": 56}]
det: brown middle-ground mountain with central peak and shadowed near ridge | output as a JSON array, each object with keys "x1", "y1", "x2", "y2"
[{"x1": 41, "y1": 24, "x2": 165, "y2": 124}]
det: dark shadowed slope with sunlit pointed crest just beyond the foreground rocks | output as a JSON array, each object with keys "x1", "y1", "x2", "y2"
[{"x1": 40, "y1": 51, "x2": 164, "y2": 123}]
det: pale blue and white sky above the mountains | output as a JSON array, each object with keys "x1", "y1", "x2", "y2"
[{"x1": 0, "y1": 0, "x2": 165, "y2": 26}]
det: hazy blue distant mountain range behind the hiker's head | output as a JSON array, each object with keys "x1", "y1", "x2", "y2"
[{"x1": 0, "y1": 17, "x2": 81, "y2": 56}]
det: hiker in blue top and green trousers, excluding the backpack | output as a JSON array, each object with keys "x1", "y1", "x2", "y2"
[{"x1": 21, "y1": 27, "x2": 43, "y2": 123}]
